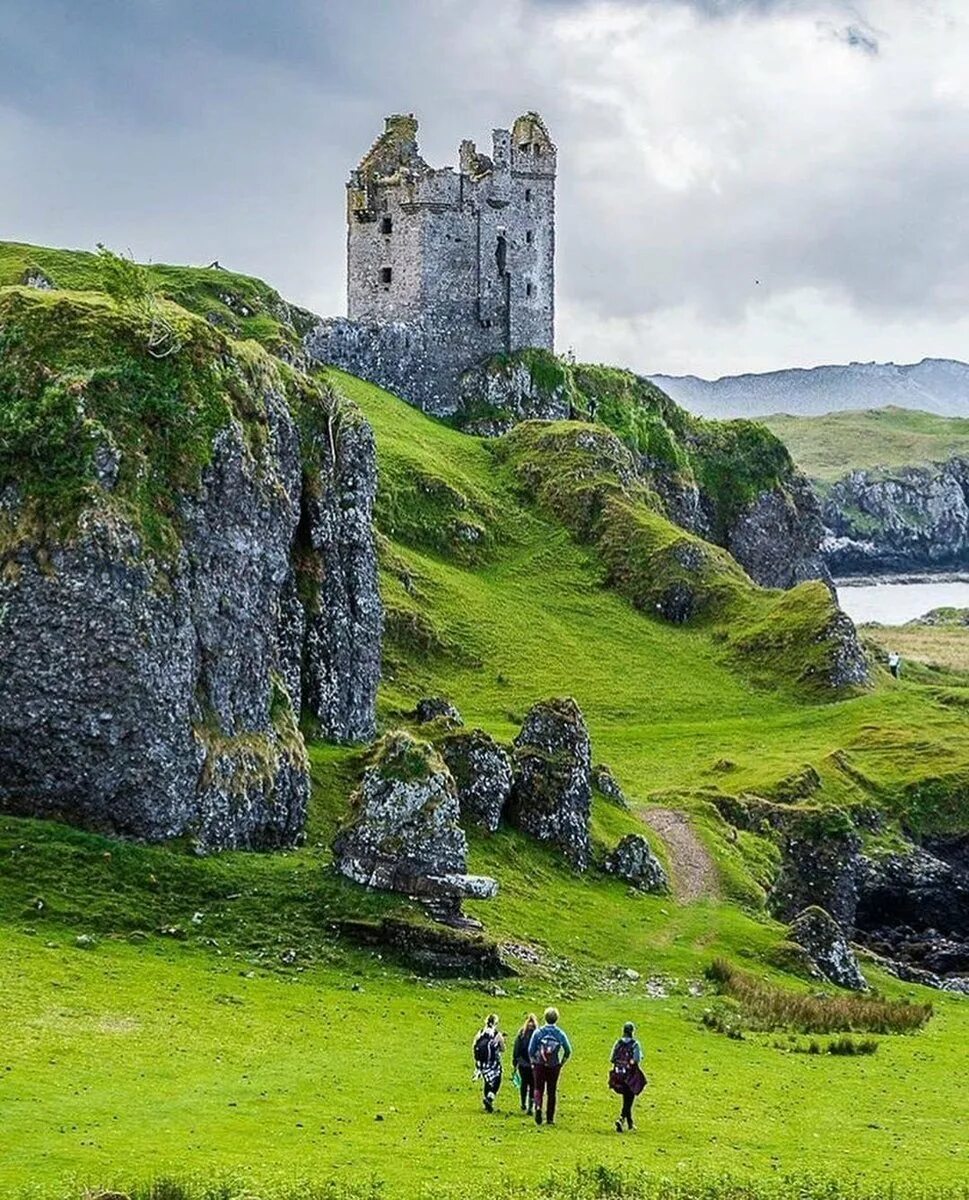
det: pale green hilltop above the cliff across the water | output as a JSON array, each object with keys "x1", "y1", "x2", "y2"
[{"x1": 763, "y1": 407, "x2": 969, "y2": 484}]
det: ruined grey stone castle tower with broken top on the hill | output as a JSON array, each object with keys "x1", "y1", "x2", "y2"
[{"x1": 308, "y1": 113, "x2": 555, "y2": 416}]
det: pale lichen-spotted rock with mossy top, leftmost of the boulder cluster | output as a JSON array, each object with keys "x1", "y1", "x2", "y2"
[{"x1": 333, "y1": 731, "x2": 498, "y2": 907}]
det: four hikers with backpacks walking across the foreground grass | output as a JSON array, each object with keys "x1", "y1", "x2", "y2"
[{"x1": 471, "y1": 1008, "x2": 646, "y2": 1133}]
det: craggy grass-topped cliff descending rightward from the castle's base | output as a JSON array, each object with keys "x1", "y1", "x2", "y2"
[{"x1": 458, "y1": 349, "x2": 830, "y2": 588}]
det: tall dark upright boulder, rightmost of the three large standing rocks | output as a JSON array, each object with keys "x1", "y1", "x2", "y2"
[{"x1": 507, "y1": 698, "x2": 592, "y2": 870}]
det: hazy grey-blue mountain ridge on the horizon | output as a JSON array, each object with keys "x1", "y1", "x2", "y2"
[{"x1": 650, "y1": 359, "x2": 969, "y2": 416}]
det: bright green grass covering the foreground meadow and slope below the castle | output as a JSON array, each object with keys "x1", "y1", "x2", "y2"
[{"x1": 0, "y1": 247, "x2": 969, "y2": 1200}]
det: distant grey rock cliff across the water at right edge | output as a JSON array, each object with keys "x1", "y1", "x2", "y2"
[{"x1": 821, "y1": 458, "x2": 969, "y2": 575}]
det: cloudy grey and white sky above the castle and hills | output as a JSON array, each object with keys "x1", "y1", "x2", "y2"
[{"x1": 0, "y1": 0, "x2": 969, "y2": 376}]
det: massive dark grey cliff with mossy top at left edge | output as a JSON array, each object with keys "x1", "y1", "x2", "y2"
[{"x1": 0, "y1": 288, "x2": 380, "y2": 850}]
